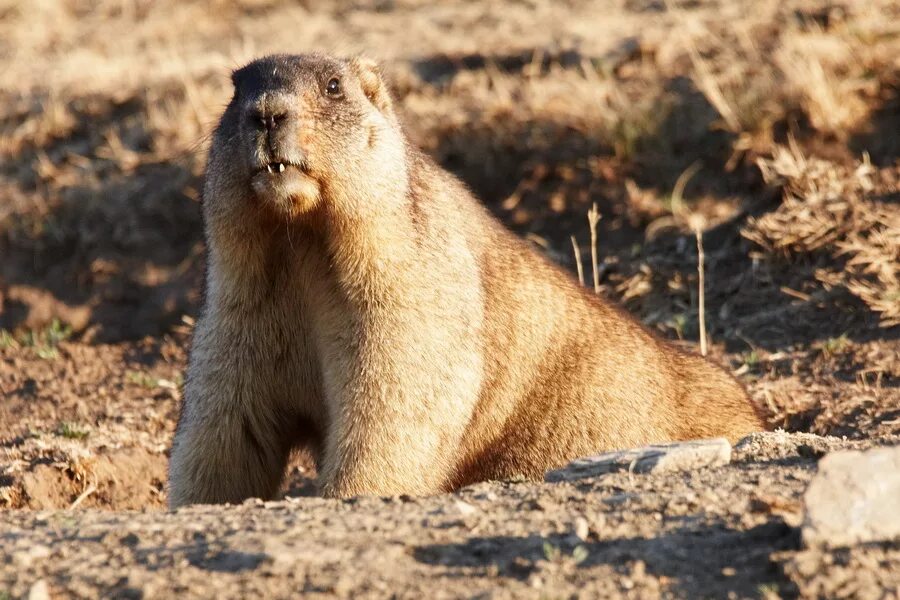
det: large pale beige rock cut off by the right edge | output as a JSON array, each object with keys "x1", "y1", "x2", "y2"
[{"x1": 802, "y1": 446, "x2": 900, "y2": 548}]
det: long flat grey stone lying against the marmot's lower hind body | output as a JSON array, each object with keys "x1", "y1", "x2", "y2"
[{"x1": 544, "y1": 438, "x2": 731, "y2": 482}]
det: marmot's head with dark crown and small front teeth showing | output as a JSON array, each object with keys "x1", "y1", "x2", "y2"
[{"x1": 205, "y1": 55, "x2": 403, "y2": 223}]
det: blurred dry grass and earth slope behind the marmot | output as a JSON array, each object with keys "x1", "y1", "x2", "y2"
[{"x1": 0, "y1": 0, "x2": 900, "y2": 507}]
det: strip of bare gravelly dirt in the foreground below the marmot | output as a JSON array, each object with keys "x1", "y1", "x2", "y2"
[{"x1": 0, "y1": 434, "x2": 900, "y2": 598}]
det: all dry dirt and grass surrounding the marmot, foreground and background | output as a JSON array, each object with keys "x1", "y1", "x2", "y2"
[{"x1": 0, "y1": 0, "x2": 900, "y2": 599}]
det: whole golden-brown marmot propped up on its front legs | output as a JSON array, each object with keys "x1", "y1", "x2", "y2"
[{"x1": 169, "y1": 55, "x2": 762, "y2": 507}]
